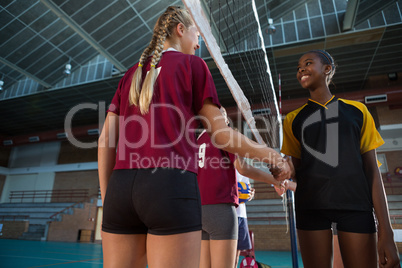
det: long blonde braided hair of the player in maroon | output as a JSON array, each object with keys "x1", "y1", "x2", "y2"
[{"x1": 129, "y1": 6, "x2": 194, "y2": 114}]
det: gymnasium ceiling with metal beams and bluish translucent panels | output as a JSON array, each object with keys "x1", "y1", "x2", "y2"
[{"x1": 0, "y1": 0, "x2": 402, "y2": 143}]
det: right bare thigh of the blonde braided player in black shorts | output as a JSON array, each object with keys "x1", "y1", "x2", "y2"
[{"x1": 147, "y1": 231, "x2": 201, "y2": 268}]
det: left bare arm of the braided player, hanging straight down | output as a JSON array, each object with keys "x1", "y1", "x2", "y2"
[{"x1": 98, "y1": 112, "x2": 119, "y2": 203}]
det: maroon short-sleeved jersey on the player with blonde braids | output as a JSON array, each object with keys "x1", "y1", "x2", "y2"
[{"x1": 108, "y1": 51, "x2": 220, "y2": 173}]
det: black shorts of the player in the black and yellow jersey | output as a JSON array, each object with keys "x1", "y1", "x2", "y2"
[{"x1": 296, "y1": 209, "x2": 377, "y2": 234}]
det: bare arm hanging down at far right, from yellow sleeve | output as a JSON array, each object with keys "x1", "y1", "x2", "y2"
[{"x1": 362, "y1": 149, "x2": 399, "y2": 267}]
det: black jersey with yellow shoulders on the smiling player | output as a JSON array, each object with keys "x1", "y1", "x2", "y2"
[{"x1": 281, "y1": 96, "x2": 384, "y2": 211}]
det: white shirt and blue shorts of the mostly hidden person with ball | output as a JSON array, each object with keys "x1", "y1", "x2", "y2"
[{"x1": 236, "y1": 170, "x2": 252, "y2": 250}]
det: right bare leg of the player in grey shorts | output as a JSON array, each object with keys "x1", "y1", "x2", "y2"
[{"x1": 209, "y1": 240, "x2": 237, "y2": 268}]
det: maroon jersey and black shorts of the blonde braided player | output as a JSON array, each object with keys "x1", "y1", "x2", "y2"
[{"x1": 102, "y1": 50, "x2": 220, "y2": 235}]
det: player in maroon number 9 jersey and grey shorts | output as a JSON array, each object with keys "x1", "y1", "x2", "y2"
[{"x1": 197, "y1": 107, "x2": 281, "y2": 268}]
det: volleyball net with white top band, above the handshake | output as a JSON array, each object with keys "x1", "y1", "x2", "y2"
[{"x1": 183, "y1": 0, "x2": 282, "y2": 149}]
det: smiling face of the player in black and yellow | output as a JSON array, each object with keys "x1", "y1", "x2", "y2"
[{"x1": 296, "y1": 52, "x2": 331, "y2": 90}]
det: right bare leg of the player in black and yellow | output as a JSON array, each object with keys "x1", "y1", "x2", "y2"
[{"x1": 338, "y1": 230, "x2": 378, "y2": 268}]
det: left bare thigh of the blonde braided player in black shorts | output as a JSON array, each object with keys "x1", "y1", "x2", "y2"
[{"x1": 102, "y1": 232, "x2": 147, "y2": 268}]
